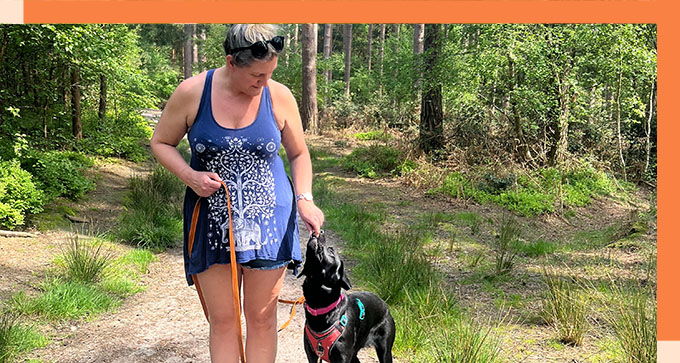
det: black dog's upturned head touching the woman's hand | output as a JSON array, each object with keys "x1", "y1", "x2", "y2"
[{"x1": 298, "y1": 231, "x2": 352, "y2": 290}]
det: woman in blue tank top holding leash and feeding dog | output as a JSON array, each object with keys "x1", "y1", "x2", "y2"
[{"x1": 151, "y1": 24, "x2": 324, "y2": 363}]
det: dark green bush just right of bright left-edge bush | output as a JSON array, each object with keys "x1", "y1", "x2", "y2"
[{"x1": 21, "y1": 150, "x2": 94, "y2": 200}]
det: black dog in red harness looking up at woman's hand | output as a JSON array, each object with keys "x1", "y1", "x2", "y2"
[{"x1": 298, "y1": 232, "x2": 395, "y2": 363}]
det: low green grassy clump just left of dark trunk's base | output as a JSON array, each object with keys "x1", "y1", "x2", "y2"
[{"x1": 341, "y1": 145, "x2": 415, "y2": 178}]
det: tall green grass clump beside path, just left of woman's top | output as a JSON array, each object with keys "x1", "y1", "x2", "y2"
[{"x1": 116, "y1": 165, "x2": 186, "y2": 250}]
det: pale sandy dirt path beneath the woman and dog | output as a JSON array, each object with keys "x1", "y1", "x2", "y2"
[{"x1": 0, "y1": 162, "x2": 377, "y2": 363}]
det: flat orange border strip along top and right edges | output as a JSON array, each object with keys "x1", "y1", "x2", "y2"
[{"x1": 10, "y1": 0, "x2": 680, "y2": 341}]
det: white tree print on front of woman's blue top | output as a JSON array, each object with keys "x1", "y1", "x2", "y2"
[{"x1": 196, "y1": 137, "x2": 278, "y2": 252}]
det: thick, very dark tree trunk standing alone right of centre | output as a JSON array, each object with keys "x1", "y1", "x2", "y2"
[{"x1": 419, "y1": 24, "x2": 444, "y2": 154}]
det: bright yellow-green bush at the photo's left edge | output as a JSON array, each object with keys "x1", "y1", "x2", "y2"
[{"x1": 0, "y1": 161, "x2": 44, "y2": 229}]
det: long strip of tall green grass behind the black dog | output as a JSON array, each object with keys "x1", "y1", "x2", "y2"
[{"x1": 314, "y1": 158, "x2": 501, "y2": 363}]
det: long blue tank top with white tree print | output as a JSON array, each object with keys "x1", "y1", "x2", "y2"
[{"x1": 184, "y1": 69, "x2": 302, "y2": 285}]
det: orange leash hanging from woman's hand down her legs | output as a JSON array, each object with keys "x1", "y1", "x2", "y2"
[{"x1": 188, "y1": 181, "x2": 246, "y2": 363}]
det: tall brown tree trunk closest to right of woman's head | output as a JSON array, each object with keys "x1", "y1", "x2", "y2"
[{"x1": 300, "y1": 24, "x2": 319, "y2": 134}]
